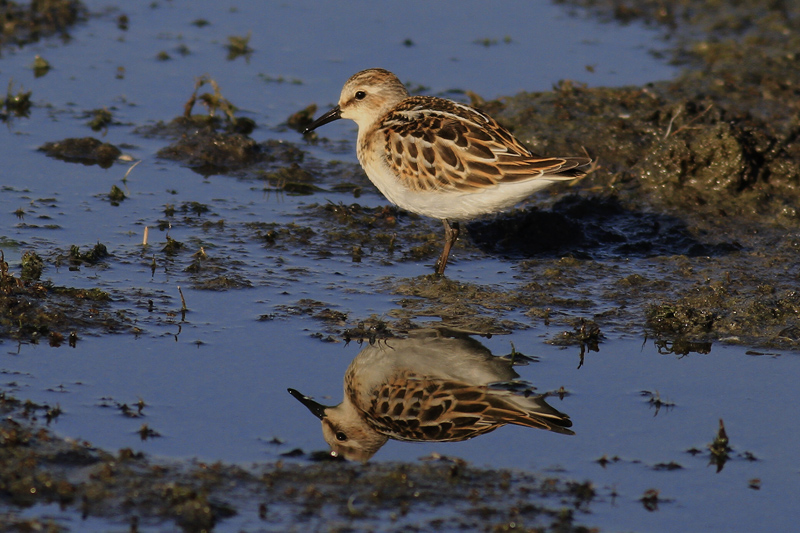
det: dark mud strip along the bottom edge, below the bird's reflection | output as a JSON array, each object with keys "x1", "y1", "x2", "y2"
[{"x1": 0, "y1": 392, "x2": 601, "y2": 532}]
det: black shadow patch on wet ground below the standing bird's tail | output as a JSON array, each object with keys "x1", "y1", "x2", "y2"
[{"x1": 467, "y1": 195, "x2": 742, "y2": 260}]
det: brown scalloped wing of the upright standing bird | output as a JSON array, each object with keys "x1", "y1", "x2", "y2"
[{"x1": 379, "y1": 96, "x2": 590, "y2": 192}]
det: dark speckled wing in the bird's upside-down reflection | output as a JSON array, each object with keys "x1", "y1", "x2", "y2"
[{"x1": 365, "y1": 377, "x2": 571, "y2": 442}]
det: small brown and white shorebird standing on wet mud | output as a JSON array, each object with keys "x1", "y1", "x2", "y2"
[{"x1": 303, "y1": 68, "x2": 591, "y2": 274}]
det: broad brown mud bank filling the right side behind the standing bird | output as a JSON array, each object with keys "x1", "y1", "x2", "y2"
[{"x1": 456, "y1": 2, "x2": 800, "y2": 347}]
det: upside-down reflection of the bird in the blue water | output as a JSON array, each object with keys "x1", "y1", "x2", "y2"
[{"x1": 289, "y1": 328, "x2": 573, "y2": 461}]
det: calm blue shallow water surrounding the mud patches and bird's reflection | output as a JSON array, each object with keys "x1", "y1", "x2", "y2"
[{"x1": 0, "y1": 2, "x2": 800, "y2": 531}]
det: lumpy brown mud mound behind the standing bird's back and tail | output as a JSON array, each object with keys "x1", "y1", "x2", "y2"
[{"x1": 498, "y1": 80, "x2": 800, "y2": 230}]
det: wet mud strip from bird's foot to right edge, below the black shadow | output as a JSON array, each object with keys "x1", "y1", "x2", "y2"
[{"x1": 374, "y1": 225, "x2": 800, "y2": 348}]
